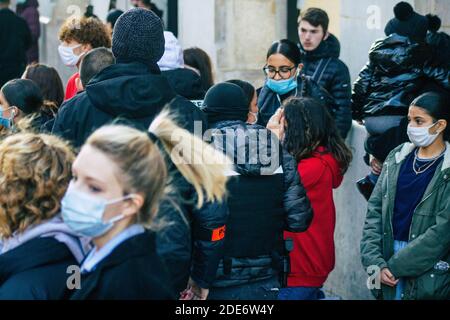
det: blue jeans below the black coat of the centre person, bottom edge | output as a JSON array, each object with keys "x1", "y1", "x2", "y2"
[{"x1": 208, "y1": 277, "x2": 280, "y2": 300}]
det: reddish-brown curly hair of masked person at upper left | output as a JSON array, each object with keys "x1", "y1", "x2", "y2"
[{"x1": 59, "y1": 17, "x2": 111, "y2": 49}]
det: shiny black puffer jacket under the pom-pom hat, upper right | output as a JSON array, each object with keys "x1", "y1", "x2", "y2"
[{"x1": 352, "y1": 34, "x2": 450, "y2": 120}]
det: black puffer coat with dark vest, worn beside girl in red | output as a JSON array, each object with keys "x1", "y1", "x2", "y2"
[{"x1": 208, "y1": 121, "x2": 313, "y2": 287}]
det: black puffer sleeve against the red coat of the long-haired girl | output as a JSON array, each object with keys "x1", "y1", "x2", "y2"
[{"x1": 281, "y1": 148, "x2": 313, "y2": 232}]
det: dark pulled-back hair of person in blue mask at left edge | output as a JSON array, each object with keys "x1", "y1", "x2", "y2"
[{"x1": 1, "y1": 79, "x2": 44, "y2": 115}]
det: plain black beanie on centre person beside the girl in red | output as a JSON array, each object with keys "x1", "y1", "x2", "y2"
[{"x1": 203, "y1": 82, "x2": 249, "y2": 126}]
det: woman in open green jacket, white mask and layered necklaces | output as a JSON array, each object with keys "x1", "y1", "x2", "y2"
[{"x1": 361, "y1": 92, "x2": 450, "y2": 300}]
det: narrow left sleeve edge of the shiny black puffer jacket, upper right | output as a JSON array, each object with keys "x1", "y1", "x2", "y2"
[{"x1": 351, "y1": 62, "x2": 374, "y2": 120}]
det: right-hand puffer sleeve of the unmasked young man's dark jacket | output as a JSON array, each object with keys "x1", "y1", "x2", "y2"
[{"x1": 330, "y1": 61, "x2": 352, "y2": 139}]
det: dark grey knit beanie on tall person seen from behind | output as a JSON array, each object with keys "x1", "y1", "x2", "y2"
[{"x1": 112, "y1": 8, "x2": 165, "y2": 72}]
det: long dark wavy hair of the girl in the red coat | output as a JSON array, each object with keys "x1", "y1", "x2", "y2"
[{"x1": 283, "y1": 98, "x2": 352, "y2": 174}]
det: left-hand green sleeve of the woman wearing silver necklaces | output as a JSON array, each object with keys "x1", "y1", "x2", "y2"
[{"x1": 360, "y1": 159, "x2": 392, "y2": 269}]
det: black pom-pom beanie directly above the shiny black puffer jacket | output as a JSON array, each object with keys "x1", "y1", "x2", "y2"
[{"x1": 384, "y1": 1, "x2": 428, "y2": 41}]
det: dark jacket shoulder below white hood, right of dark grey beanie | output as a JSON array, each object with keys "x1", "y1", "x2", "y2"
[{"x1": 161, "y1": 68, "x2": 206, "y2": 100}]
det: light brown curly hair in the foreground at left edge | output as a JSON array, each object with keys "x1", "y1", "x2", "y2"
[{"x1": 0, "y1": 133, "x2": 75, "y2": 238}]
